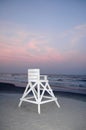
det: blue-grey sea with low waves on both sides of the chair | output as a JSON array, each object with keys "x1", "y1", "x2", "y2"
[{"x1": 0, "y1": 73, "x2": 86, "y2": 91}]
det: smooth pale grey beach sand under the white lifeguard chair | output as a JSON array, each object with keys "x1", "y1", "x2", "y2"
[{"x1": 0, "y1": 92, "x2": 86, "y2": 130}]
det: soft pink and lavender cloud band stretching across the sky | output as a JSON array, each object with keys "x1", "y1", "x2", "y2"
[{"x1": 0, "y1": 21, "x2": 86, "y2": 70}]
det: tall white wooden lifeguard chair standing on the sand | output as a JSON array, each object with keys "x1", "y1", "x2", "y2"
[{"x1": 19, "y1": 69, "x2": 60, "y2": 114}]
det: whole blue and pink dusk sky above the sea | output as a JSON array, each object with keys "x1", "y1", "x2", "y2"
[{"x1": 0, "y1": 0, "x2": 86, "y2": 74}]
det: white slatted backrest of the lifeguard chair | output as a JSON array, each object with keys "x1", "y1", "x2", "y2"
[{"x1": 28, "y1": 69, "x2": 40, "y2": 82}]
